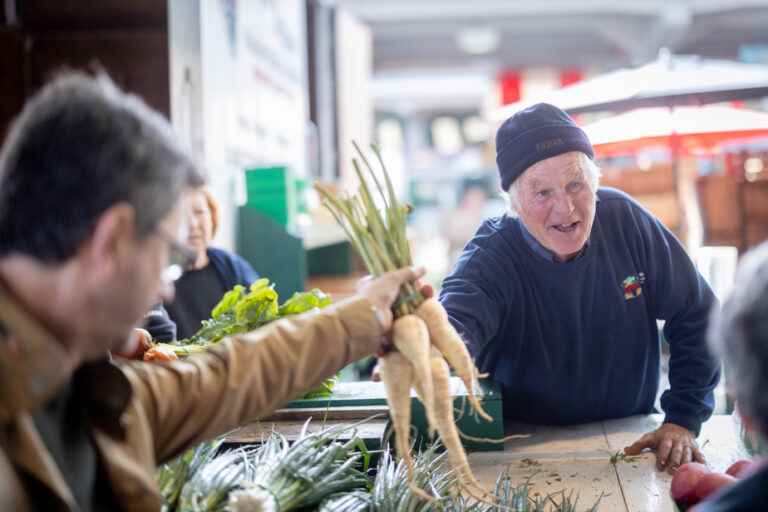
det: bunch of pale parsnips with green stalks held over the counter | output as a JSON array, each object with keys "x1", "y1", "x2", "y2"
[{"x1": 315, "y1": 143, "x2": 492, "y2": 496}]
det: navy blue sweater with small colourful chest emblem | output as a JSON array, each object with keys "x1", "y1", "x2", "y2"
[{"x1": 440, "y1": 189, "x2": 720, "y2": 433}]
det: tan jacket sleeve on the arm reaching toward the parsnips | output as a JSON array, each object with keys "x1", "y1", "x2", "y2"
[{"x1": 123, "y1": 298, "x2": 382, "y2": 462}]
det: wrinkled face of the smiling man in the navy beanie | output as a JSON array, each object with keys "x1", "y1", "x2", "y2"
[{"x1": 518, "y1": 151, "x2": 596, "y2": 261}]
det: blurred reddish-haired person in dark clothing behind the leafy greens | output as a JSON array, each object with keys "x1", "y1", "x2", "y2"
[{"x1": 165, "y1": 187, "x2": 258, "y2": 339}]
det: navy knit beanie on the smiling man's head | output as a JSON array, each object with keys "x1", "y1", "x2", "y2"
[{"x1": 496, "y1": 103, "x2": 594, "y2": 190}]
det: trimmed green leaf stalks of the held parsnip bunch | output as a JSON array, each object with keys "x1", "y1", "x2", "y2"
[{"x1": 315, "y1": 142, "x2": 424, "y2": 318}]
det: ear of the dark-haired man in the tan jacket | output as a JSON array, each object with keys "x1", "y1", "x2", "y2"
[{"x1": 83, "y1": 203, "x2": 136, "y2": 277}]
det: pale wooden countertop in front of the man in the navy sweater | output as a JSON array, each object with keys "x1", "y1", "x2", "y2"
[{"x1": 469, "y1": 415, "x2": 748, "y2": 512}]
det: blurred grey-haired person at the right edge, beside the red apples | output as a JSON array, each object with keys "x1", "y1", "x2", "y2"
[{"x1": 695, "y1": 243, "x2": 768, "y2": 512}]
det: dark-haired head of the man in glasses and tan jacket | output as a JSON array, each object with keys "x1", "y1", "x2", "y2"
[{"x1": 0, "y1": 73, "x2": 202, "y2": 360}]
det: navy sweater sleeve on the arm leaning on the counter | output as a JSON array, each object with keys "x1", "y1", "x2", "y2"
[{"x1": 641, "y1": 206, "x2": 720, "y2": 435}]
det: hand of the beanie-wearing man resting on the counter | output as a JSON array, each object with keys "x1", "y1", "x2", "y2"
[{"x1": 624, "y1": 423, "x2": 706, "y2": 473}]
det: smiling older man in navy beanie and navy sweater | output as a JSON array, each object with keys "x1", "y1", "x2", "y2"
[{"x1": 440, "y1": 104, "x2": 719, "y2": 468}]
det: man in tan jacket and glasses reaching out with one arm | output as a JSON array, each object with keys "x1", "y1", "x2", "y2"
[{"x1": 0, "y1": 75, "x2": 422, "y2": 511}]
